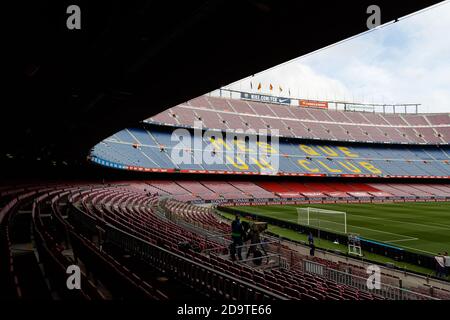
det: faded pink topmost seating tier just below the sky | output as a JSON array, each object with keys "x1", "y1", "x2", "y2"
[{"x1": 147, "y1": 96, "x2": 450, "y2": 144}]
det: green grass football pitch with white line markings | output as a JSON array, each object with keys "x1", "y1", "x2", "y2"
[{"x1": 235, "y1": 202, "x2": 450, "y2": 254}]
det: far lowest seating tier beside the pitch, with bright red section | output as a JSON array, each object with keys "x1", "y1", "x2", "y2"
[{"x1": 97, "y1": 180, "x2": 450, "y2": 202}]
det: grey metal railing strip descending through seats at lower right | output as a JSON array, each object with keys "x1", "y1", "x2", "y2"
[{"x1": 303, "y1": 260, "x2": 440, "y2": 300}]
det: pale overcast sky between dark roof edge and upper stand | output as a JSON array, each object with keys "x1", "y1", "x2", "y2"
[{"x1": 224, "y1": 2, "x2": 450, "y2": 112}]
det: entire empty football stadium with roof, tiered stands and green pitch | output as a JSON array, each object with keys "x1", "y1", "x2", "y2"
[{"x1": 0, "y1": 1, "x2": 450, "y2": 303}]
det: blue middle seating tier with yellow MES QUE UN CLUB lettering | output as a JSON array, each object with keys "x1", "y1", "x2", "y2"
[{"x1": 91, "y1": 128, "x2": 450, "y2": 180}]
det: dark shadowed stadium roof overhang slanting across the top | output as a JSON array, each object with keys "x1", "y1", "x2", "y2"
[{"x1": 7, "y1": 0, "x2": 439, "y2": 174}]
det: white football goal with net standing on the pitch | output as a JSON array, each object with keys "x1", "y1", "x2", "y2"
[{"x1": 297, "y1": 207, "x2": 347, "y2": 234}]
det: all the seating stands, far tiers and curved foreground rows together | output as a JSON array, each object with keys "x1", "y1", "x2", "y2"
[{"x1": 0, "y1": 96, "x2": 450, "y2": 300}]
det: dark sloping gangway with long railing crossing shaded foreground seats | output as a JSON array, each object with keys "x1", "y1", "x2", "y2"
[{"x1": 69, "y1": 206, "x2": 289, "y2": 301}]
